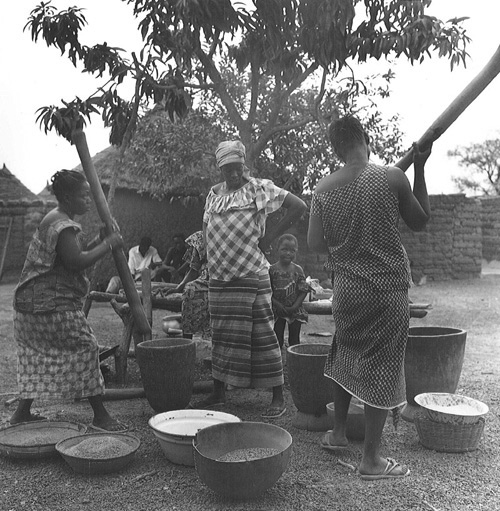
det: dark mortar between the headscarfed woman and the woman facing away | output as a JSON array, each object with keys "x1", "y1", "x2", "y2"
[{"x1": 287, "y1": 344, "x2": 333, "y2": 431}]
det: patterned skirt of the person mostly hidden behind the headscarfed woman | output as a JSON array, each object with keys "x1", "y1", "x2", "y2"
[{"x1": 182, "y1": 279, "x2": 212, "y2": 340}]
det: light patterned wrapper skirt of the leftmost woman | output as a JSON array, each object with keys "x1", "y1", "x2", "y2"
[{"x1": 14, "y1": 311, "x2": 104, "y2": 400}]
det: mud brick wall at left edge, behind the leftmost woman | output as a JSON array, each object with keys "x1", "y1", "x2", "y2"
[{"x1": 0, "y1": 199, "x2": 57, "y2": 280}]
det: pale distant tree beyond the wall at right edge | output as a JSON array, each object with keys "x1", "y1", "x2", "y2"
[{"x1": 448, "y1": 138, "x2": 500, "y2": 195}]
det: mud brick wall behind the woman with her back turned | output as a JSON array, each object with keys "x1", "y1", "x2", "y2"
[{"x1": 297, "y1": 194, "x2": 482, "y2": 281}]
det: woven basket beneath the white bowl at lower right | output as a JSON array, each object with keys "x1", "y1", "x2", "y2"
[{"x1": 414, "y1": 412, "x2": 485, "y2": 452}]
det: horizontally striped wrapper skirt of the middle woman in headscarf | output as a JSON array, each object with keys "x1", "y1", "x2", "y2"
[{"x1": 209, "y1": 272, "x2": 283, "y2": 388}]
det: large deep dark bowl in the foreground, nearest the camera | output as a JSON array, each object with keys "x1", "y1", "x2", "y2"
[{"x1": 193, "y1": 422, "x2": 292, "y2": 499}]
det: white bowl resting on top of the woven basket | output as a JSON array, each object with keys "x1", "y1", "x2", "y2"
[{"x1": 415, "y1": 392, "x2": 489, "y2": 425}]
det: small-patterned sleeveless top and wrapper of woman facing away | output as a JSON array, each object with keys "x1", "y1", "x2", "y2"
[{"x1": 311, "y1": 163, "x2": 410, "y2": 409}]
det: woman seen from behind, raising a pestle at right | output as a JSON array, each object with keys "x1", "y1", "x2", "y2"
[{"x1": 308, "y1": 116, "x2": 431, "y2": 479}]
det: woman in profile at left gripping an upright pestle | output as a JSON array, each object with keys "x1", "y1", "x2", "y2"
[{"x1": 10, "y1": 170, "x2": 124, "y2": 431}]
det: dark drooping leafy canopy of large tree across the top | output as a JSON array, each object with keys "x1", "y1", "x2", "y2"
[{"x1": 25, "y1": 0, "x2": 469, "y2": 195}]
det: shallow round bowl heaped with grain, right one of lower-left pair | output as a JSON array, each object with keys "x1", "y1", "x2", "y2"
[{"x1": 56, "y1": 433, "x2": 141, "y2": 475}]
